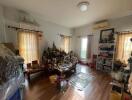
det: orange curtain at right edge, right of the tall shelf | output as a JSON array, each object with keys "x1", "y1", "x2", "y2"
[{"x1": 116, "y1": 33, "x2": 132, "y2": 64}]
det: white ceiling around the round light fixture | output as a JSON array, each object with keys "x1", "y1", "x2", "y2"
[{"x1": 0, "y1": 0, "x2": 132, "y2": 28}]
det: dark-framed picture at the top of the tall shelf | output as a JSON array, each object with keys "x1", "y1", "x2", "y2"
[{"x1": 99, "y1": 28, "x2": 115, "y2": 43}]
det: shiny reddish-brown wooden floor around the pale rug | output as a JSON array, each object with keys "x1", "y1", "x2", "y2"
[{"x1": 24, "y1": 64, "x2": 111, "y2": 100}]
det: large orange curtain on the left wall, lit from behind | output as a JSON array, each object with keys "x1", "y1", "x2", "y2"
[{"x1": 18, "y1": 31, "x2": 39, "y2": 63}]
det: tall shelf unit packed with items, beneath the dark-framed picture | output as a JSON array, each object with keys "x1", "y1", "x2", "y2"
[{"x1": 96, "y1": 31, "x2": 116, "y2": 72}]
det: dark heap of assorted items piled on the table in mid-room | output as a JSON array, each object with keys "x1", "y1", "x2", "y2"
[{"x1": 42, "y1": 44, "x2": 78, "y2": 75}]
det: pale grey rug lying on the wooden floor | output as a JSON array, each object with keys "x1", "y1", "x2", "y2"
[{"x1": 69, "y1": 73, "x2": 94, "y2": 91}]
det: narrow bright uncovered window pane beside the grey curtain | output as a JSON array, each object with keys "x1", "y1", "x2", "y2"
[{"x1": 81, "y1": 37, "x2": 88, "y2": 59}]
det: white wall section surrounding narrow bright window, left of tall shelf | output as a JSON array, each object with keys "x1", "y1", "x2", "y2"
[{"x1": 73, "y1": 24, "x2": 99, "y2": 56}]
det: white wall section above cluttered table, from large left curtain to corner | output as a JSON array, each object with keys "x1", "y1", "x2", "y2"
[{"x1": 37, "y1": 20, "x2": 72, "y2": 55}]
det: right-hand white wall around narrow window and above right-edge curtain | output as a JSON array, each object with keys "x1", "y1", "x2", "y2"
[{"x1": 73, "y1": 15, "x2": 132, "y2": 58}]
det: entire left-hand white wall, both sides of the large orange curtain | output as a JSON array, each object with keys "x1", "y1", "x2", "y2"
[{"x1": 0, "y1": 6, "x2": 72, "y2": 55}]
